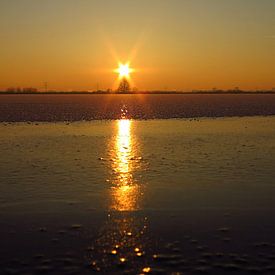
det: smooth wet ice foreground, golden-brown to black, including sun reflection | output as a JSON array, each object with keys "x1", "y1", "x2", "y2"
[{"x1": 0, "y1": 117, "x2": 275, "y2": 274}]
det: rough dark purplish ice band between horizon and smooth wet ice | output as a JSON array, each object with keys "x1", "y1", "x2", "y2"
[{"x1": 0, "y1": 94, "x2": 275, "y2": 122}]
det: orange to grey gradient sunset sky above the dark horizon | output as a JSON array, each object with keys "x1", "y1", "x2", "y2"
[{"x1": 0, "y1": 0, "x2": 275, "y2": 90}]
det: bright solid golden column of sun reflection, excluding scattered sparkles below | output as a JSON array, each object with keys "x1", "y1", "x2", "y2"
[{"x1": 111, "y1": 119, "x2": 140, "y2": 211}]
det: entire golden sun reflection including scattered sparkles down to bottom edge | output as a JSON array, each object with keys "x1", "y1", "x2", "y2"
[{"x1": 91, "y1": 118, "x2": 152, "y2": 274}]
